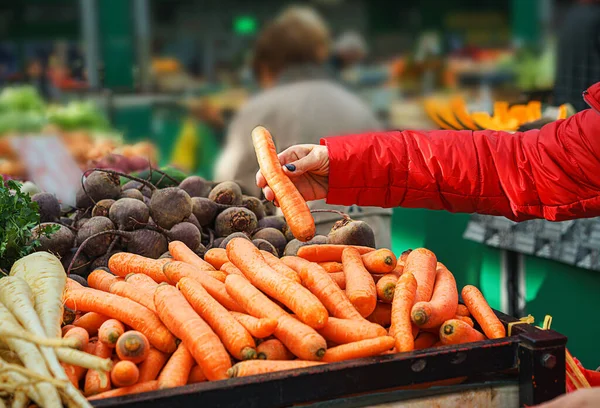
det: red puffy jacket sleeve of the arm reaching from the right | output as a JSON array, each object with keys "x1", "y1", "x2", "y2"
[{"x1": 321, "y1": 83, "x2": 600, "y2": 221}]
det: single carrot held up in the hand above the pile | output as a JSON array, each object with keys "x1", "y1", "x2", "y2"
[{"x1": 252, "y1": 126, "x2": 316, "y2": 242}]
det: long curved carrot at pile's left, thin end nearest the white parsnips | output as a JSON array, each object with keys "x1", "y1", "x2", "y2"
[{"x1": 63, "y1": 288, "x2": 176, "y2": 353}]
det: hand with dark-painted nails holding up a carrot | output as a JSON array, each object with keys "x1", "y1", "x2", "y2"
[{"x1": 256, "y1": 144, "x2": 329, "y2": 201}]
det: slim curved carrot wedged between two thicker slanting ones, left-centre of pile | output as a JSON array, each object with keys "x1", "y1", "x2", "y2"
[{"x1": 163, "y1": 261, "x2": 244, "y2": 312}]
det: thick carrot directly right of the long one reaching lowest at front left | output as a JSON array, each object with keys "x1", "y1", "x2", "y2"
[{"x1": 177, "y1": 278, "x2": 256, "y2": 360}]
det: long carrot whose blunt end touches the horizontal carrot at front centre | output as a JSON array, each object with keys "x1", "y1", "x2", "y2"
[{"x1": 225, "y1": 275, "x2": 327, "y2": 360}]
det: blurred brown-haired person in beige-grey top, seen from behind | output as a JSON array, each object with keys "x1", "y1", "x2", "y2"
[{"x1": 215, "y1": 7, "x2": 391, "y2": 248}]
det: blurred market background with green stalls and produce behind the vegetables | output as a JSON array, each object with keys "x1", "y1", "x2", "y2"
[{"x1": 0, "y1": 0, "x2": 600, "y2": 364}]
